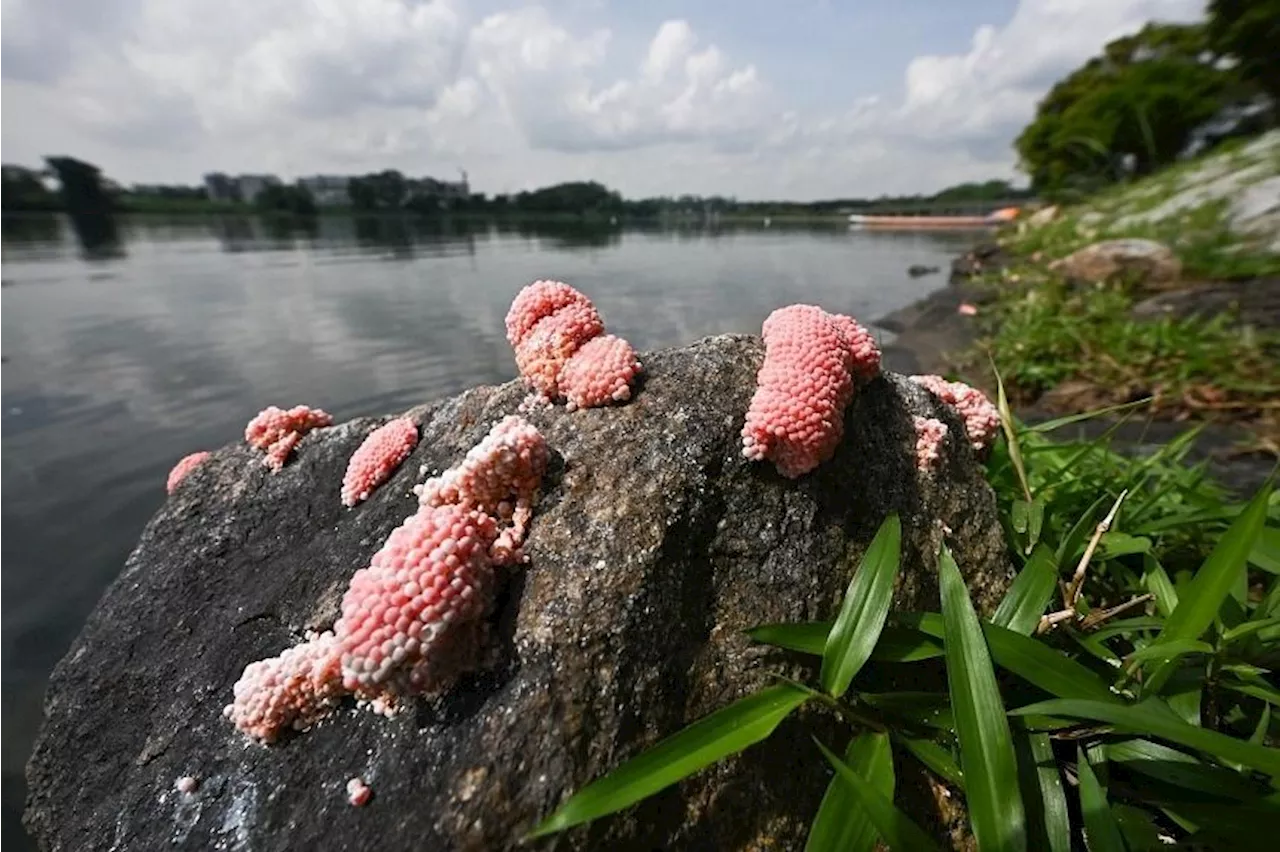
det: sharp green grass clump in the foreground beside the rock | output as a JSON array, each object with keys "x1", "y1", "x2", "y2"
[{"x1": 522, "y1": 388, "x2": 1280, "y2": 852}]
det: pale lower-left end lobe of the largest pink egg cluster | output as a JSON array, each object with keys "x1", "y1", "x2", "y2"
[{"x1": 223, "y1": 632, "x2": 342, "y2": 742}]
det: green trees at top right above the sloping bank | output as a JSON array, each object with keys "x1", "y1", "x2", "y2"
[{"x1": 1015, "y1": 0, "x2": 1280, "y2": 197}]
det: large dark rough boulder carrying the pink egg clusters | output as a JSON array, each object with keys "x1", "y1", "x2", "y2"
[{"x1": 26, "y1": 336, "x2": 1009, "y2": 852}]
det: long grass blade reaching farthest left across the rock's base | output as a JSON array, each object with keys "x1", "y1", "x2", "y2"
[{"x1": 529, "y1": 683, "x2": 810, "y2": 838}]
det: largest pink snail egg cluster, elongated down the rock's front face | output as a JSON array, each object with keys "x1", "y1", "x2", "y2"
[{"x1": 225, "y1": 417, "x2": 549, "y2": 743}]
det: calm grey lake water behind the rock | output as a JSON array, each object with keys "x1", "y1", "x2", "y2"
[{"x1": 0, "y1": 217, "x2": 974, "y2": 849}]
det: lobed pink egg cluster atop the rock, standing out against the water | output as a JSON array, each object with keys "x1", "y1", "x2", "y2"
[{"x1": 506, "y1": 280, "x2": 641, "y2": 408}]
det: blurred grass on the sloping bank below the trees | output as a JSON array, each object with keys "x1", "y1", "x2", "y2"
[{"x1": 963, "y1": 137, "x2": 1280, "y2": 445}]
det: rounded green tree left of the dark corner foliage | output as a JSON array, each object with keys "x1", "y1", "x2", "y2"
[{"x1": 1015, "y1": 24, "x2": 1240, "y2": 194}]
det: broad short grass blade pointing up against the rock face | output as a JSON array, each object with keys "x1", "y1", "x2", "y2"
[{"x1": 822, "y1": 512, "x2": 902, "y2": 698}]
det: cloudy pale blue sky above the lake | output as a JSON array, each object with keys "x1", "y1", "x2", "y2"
[{"x1": 0, "y1": 0, "x2": 1204, "y2": 198}]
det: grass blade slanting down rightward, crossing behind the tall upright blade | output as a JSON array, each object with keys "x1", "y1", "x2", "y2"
[{"x1": 902, "y1": 613, "x2": 1120, "y2": 702}]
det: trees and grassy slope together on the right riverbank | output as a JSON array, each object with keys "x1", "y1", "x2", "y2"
[{"x1": 964, "y1": 0, "x2": 1280, "y2": 455}]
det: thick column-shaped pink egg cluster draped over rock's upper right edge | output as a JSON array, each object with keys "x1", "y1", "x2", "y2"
[{"x1": 742, "y1": 304, "x2": 879, "y2": 478}]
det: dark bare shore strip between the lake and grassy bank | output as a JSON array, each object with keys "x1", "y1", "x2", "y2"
[{"x1": 872, "y1": 243, "x2": 1275, "y2": 498}]
